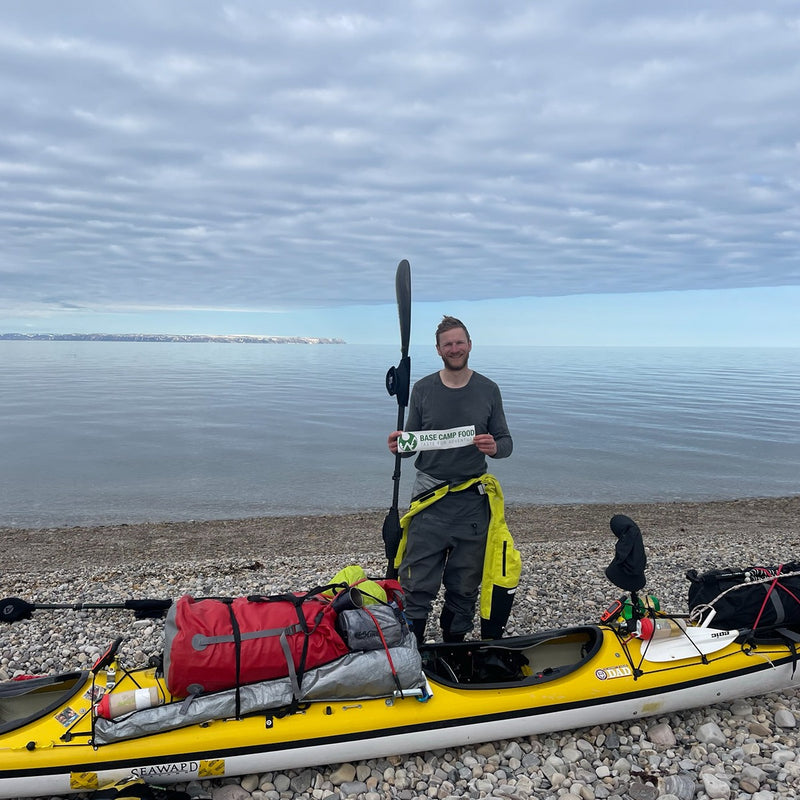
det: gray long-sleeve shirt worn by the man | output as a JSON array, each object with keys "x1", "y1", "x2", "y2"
[{"x1": 405, "y1": 372, "x2": 513, "y2": 488}]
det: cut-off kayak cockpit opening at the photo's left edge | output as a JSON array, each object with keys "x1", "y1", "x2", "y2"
[{"x1": 0, "y1": 671, "x2": 89, "y2": 733}]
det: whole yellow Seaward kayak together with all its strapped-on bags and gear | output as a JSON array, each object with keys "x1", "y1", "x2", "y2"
[{"x1": 0, "y1": 515, "x2": 800, "y2": 798}]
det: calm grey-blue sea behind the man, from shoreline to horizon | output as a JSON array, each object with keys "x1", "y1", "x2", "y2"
[{"x1": 0, "y1": 342, "x2": 800, "y2": 527}]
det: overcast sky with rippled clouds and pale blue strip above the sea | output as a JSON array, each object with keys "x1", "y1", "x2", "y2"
[{"x1": 0, "y1": 0, "x2": 800, "y2": 346}]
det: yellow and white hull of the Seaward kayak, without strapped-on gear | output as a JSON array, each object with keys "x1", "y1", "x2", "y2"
[{"x1": 0, "y1": 626, "x2": 797, "y2": 798}]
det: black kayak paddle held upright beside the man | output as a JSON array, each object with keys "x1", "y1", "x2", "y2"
[{"x1": 382, "y1": 259, "x2": 411, "y2": 578}]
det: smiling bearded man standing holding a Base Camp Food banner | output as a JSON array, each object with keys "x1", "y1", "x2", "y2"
[{"x1": 388, "y1": 316, "x2": 513, "y2": 642}]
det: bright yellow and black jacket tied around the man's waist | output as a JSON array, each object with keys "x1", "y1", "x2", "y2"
[{"x1": 394, "y1": 473, "x2": 522, "y2": 639}]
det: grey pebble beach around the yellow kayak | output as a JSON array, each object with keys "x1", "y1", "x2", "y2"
[{"x1": 0, "y1": 496, "x2": 800, "y2": 800}]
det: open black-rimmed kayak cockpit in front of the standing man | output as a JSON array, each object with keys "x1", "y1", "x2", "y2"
[{"x1": 420, "y1": 625, "x2": 603, "y2": 689}]
